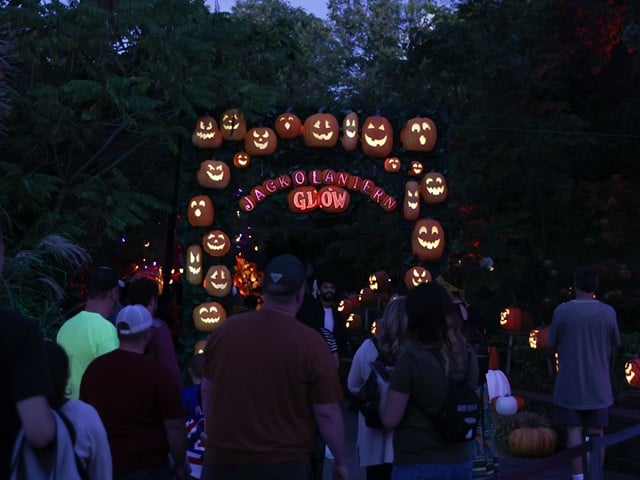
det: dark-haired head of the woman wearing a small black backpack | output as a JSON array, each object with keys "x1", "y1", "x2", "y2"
[{"x1": 406, "y1": 282, "x2": 451, "y2": 347}]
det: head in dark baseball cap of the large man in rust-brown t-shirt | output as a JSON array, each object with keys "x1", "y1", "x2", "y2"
[{"x1": 262, "y1": 254, "x2": 306, "y2": 311}]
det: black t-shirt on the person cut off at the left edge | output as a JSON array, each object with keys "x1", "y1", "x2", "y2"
[{"x1": 0, "y1": 309, "x2": 51, "y2": 478}]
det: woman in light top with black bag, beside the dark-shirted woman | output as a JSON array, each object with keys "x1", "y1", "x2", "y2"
[{"x1": 347, "y1": 297, "x2": 407, "y2": 480}]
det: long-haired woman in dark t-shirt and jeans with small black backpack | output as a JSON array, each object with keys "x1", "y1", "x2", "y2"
[{"x1": 378, "y1": 282, "x2": 480, "y2": 480}]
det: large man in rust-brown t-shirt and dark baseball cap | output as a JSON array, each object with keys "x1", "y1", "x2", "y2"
[{"x1": 201, "y1": 254, "x2": 348, "y2": 480}]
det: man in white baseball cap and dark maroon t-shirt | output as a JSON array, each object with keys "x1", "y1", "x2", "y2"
[{"x1": 80, "y1": 305, "x2": 186, "y2": 480}]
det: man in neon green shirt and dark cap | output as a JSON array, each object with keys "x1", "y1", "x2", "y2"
[{"x1": 56, "y1": 266, "x2": 124, "y2": 399}]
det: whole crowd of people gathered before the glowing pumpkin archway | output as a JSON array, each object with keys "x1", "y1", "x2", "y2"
[{"x1": 0, "y1": 236, "x2": 620, "y2": 480}]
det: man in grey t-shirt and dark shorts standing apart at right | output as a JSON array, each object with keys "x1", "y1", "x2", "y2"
[{"x1": 549, "y1": 266, "x2": 620, "y2": 480}]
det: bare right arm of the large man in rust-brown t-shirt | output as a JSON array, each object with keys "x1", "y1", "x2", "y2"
[{"x1": 313, "y1": 402, "x2": 349, "y2": 480}]
